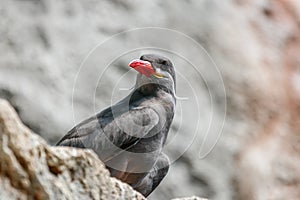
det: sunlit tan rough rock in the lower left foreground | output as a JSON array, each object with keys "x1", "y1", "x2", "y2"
[{"x1": 0, "y1": 100, "x2": 145, "y2": 200}]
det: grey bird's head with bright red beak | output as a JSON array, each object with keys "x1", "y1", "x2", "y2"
[{"x1": 129, "y1": 54, "x2": 176, "y2": 95}]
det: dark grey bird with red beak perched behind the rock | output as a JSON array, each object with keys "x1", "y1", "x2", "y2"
[{"x1": 56, "y1": 54, "x2": 176, "y2": 197}]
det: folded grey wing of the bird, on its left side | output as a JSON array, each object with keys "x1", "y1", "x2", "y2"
[{"x1": 57, "y1": 107, "x2": 160, "y2": 159}]
